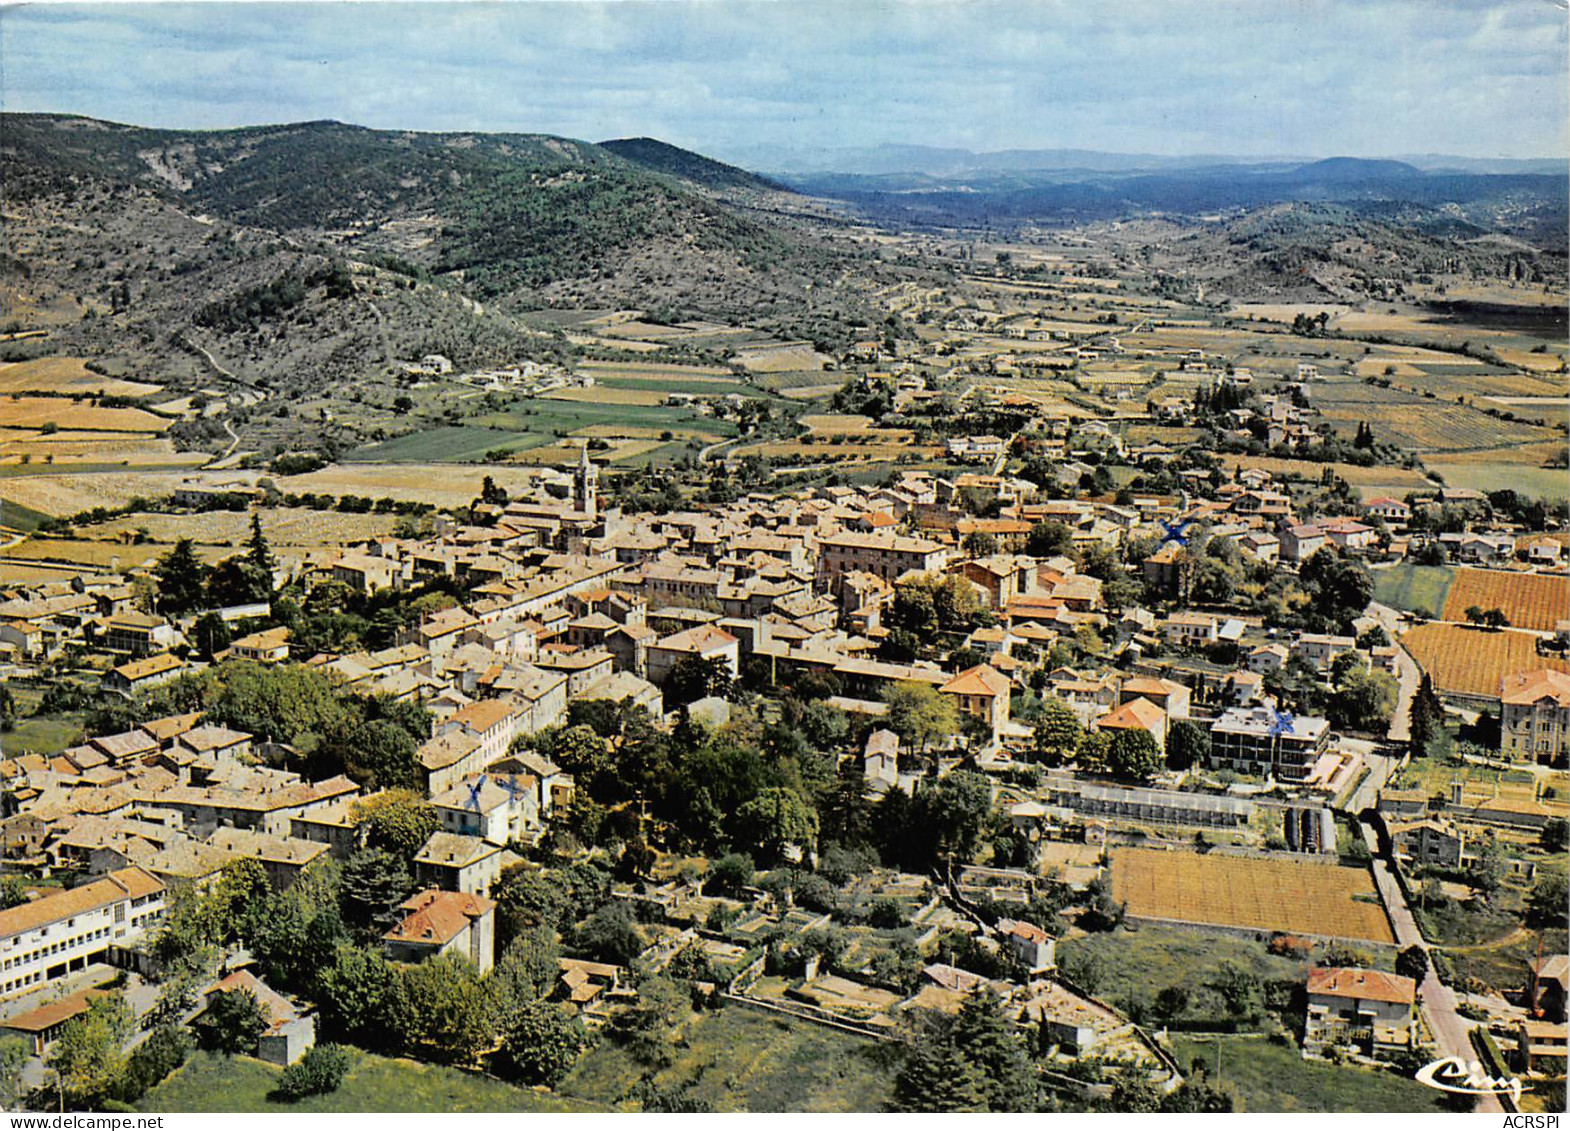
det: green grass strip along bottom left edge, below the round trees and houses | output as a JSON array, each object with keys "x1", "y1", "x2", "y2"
[{"x1": 137, "y1": 1051, "x2": 601, "y2": 1115}]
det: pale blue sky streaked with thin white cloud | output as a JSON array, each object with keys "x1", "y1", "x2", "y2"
[{"x1": 0, "y1": 0, "x2": 1570, "y2": 167}]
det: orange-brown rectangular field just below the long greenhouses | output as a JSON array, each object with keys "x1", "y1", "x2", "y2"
[{"x1": 1112, "y1": 848, "x2": 1396, "y2": 944}]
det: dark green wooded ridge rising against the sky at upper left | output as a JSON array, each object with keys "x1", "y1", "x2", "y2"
[{"x1": 0, "y1": 115, "x2": 860, "y2": 308}]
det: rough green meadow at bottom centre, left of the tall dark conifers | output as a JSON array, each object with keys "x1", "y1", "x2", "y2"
[{"x1": 557, "y1": 1005, "x2": 895, "y2": 1112}]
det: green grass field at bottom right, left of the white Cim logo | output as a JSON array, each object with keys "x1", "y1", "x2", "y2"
[{"x1": 1171, "y1": 1037, "x2": 1444, "y2": 1112}]
